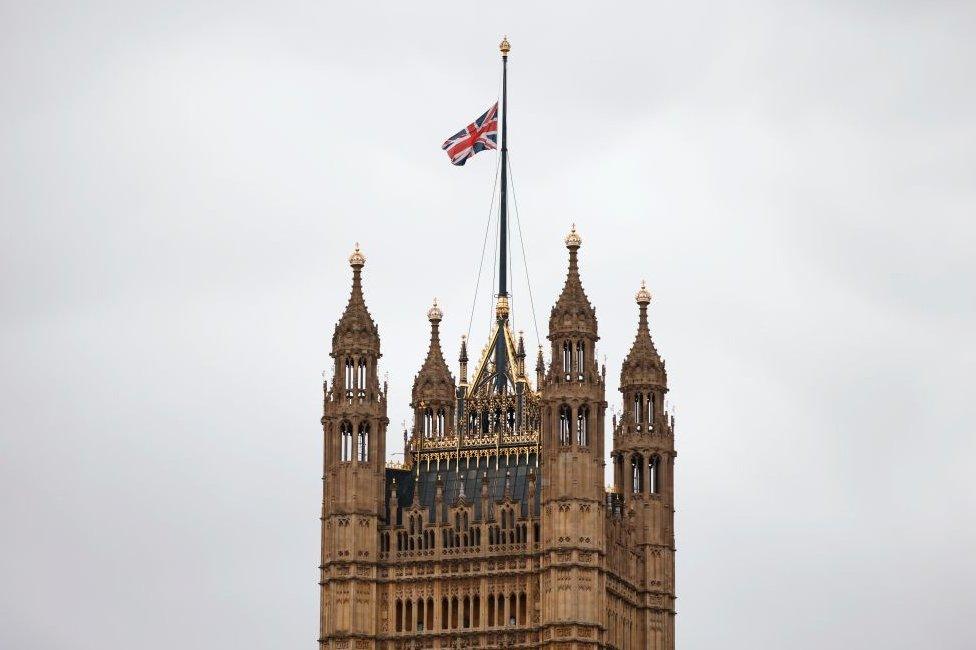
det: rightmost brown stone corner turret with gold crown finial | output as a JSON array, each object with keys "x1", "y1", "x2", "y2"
[{"x1": 612, "y1": 283, "x2": 676, "y2": 650}]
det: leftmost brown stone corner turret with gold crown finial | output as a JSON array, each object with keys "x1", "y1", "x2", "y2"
[{"x1": 319, "y1": 244, "x2": 389, "y2": 648}]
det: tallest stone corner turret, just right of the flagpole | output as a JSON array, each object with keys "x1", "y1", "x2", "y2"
[{"x1": 540, "y1": 226, "x2": 606, "y2": 648}]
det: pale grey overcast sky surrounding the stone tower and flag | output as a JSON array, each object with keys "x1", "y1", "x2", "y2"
[{"x1": 0, "y1": 1, "x2": 976, "y2": 650}]
